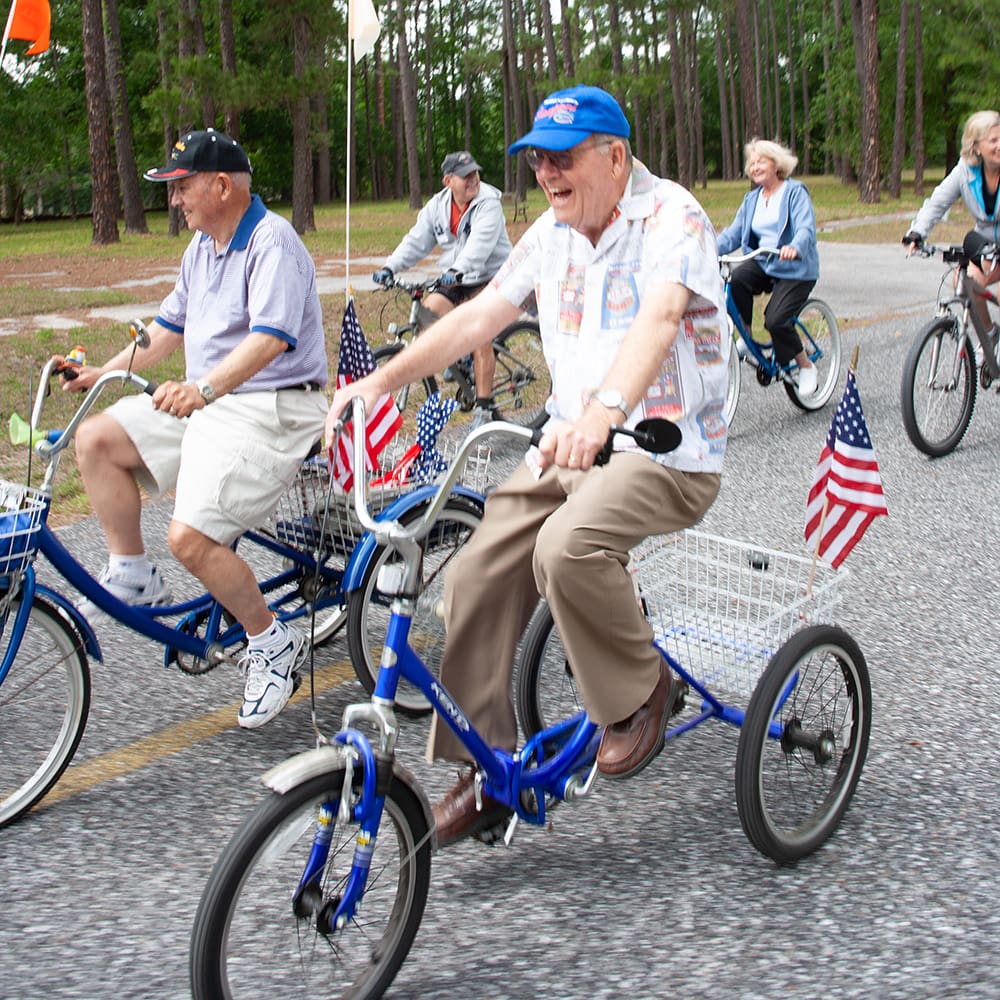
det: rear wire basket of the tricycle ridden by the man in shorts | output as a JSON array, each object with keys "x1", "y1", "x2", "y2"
[{"x1": 262, "y1": 439, "x2": 491, "y2": 556}]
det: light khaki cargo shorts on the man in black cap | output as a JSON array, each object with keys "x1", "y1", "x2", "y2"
[{"x1": 107, "y1": 389, "x2": 328, "y2": 545}]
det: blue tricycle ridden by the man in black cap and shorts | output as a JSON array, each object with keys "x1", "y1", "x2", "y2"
[{"x1": 0, "y1": 340, "x2": 483, "y2": 826}]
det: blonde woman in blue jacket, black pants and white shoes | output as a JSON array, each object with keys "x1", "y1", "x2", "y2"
[{"x1": 719, "y1": 139, "x2": 819, "y2": 396}]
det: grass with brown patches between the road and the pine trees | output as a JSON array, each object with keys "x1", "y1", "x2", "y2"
[{"x1": 0, "y1": 171, "x2": 971, "y2": 523}]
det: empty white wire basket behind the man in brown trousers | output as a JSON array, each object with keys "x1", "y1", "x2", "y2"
[{"x1": 631, "y1": 529, "x2": 848, "y2": 705}]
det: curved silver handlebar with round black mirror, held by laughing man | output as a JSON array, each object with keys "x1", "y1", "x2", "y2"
[{"x1": 336, "y1": 396, "x2": 681, "y2": 546}]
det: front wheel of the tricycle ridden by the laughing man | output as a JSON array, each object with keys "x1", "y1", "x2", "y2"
[{"x1": 190, "y1": 767, "x2": 431, "y2": 1000}]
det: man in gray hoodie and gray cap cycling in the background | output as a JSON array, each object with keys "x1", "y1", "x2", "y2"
[{"x1": 372, "y1": 149, "x2": 511, "y2": 427}]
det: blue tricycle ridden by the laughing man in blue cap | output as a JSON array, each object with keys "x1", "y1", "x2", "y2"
[{"x1": 190, "y1": 400, "x2": 871, "y2": 1000}]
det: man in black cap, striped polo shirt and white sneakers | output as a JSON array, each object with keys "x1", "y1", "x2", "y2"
[{"x1": 63, "y1": 129, "x2": 327, "y2": 729}]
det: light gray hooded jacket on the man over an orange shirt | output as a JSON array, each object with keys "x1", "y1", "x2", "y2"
[{"x1": 384, "y1": 184, "x2": 511, "y2": 285}]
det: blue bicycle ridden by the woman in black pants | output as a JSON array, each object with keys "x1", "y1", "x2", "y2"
[{"x1": 719, "y1": 247, "x2": 841, "y2": 427}]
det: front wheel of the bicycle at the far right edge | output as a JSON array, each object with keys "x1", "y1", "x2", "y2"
[{"x1": 899, "y1": 316, "x2": 976, "y2": 458}]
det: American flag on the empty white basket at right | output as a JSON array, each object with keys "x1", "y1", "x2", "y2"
[{"x1": 805, "y1": 371, "x2": 889, "y2": 569}]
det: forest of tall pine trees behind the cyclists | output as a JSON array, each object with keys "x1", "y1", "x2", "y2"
[{"x1": 0, "y1": 0, "x2": 1000, "y2": 245}]
